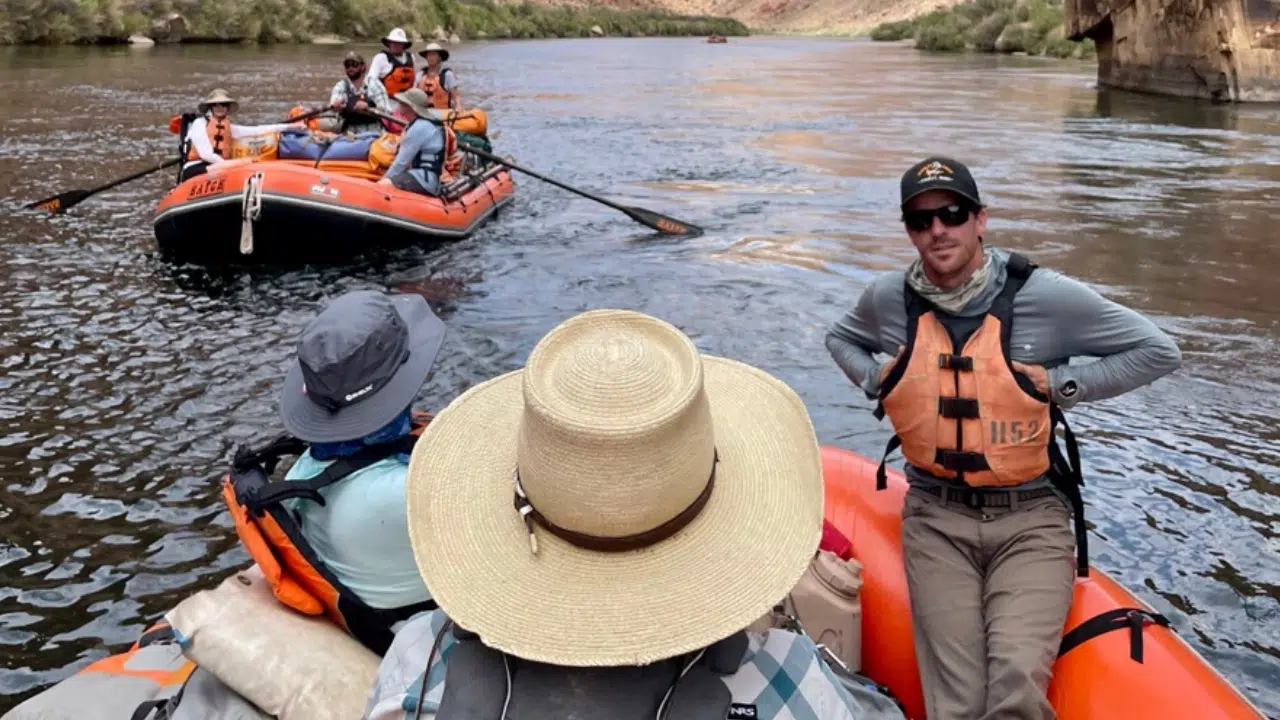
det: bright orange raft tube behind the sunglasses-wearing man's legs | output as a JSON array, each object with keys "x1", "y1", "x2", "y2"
[{"x1": 822, "y1": 447, "x2": 1263, "y2": 720}]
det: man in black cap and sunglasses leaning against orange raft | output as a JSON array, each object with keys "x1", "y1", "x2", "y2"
[{"x1": 827, "y1": 158, "x2": 1181, "y2": 720}]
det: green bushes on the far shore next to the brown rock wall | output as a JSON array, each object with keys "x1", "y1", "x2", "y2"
[{"x1": 872, "y1": 0, "x2": 1096, "y2": 58}]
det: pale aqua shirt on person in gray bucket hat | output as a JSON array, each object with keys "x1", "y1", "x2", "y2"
[{"x1": 284, "y1": 450, "x2": 431, "y2": 609}]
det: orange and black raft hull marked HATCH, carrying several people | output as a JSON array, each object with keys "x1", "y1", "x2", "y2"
[{"x1": 152, "y1": 144, "x2": 515, "y2": 261}]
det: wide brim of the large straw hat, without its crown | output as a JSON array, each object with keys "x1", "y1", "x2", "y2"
[{"x1": 406, "y1": 355, "x2": 823, "y2": 666}]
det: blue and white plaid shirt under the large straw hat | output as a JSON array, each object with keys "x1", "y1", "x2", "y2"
[{"x1": 364, "y1": 610, "x2": 904, "y2": 720}]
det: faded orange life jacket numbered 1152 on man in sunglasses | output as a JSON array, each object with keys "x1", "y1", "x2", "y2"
[{"x1": 876, "y1": 252, "x2": 1087, "y2": 568}]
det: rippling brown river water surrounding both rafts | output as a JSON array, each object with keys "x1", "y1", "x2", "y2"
[{"x1": 0, "y1": 38, "x2": 1280, "y2": 716}]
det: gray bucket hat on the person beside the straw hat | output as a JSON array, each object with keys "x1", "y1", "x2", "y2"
[{"x1": 280, "y1": 291, "x2": 445, "y2": 442}]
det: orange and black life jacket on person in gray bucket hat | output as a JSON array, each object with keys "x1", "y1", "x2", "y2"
[{"x1": 223, "y1": 413, "x2": 436, "y2": 655}]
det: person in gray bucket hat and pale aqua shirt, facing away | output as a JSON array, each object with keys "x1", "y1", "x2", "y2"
[{"x1": 223, "y1": 291, "x2": 444, "y2": 653}]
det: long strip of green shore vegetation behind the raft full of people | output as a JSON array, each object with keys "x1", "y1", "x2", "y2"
[{"x1": 0, "y1": 0, "x2": 748, "y2": 45}]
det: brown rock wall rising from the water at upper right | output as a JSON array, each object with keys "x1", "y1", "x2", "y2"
[{"x1": 1065, "y1": 0, "x2": 1280, "y2": 102}]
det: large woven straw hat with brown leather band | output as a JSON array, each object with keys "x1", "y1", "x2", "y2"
[{"x1": 406, "y1": 304, "x2": 823, "y2": 666}]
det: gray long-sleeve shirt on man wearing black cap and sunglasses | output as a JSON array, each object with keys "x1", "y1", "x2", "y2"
[{"x1": 827, "y1": 246, "x2": 1183, "y2": 487}]
